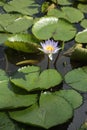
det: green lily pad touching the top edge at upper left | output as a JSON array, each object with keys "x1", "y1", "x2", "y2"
[{"x1": 4, "y1": 0, "x2": 39, "y2": 15}]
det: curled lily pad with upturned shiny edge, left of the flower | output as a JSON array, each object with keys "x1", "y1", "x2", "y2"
[{"x1": 4, "y1": 34, "x2": 40, "y2": 53}]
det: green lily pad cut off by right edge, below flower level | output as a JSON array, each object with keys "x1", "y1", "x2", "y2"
[{"x1": 65, "y1": 67, "x2": 87, "y2": 92}]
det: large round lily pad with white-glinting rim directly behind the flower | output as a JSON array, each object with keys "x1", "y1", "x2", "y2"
[{"x1": 32, "y1": 17, "x2": 76, "y2": 41}]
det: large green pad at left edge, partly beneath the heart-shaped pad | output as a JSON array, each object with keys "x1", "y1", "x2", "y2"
[{"x1": 0, "y1": 70, "x2": 37, "y2": 109}]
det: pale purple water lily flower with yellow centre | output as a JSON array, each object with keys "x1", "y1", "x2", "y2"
[{"x1": 38, "y1": 40, "x2": 61, "y2": 60}]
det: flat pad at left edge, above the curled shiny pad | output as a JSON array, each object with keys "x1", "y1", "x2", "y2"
[{"x1": 0, "y1": 14, "x2": 33, "y2": 33}]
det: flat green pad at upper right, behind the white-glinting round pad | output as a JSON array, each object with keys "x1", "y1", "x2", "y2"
[{"x1": 48, "y1": 7, "x2": 84, "y2": 23}]
